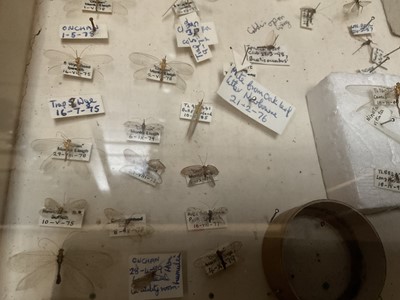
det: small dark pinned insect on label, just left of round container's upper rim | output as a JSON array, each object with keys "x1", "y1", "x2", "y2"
[{"x1": 186, "y1": 207, "x2": 228, "y2": 229}]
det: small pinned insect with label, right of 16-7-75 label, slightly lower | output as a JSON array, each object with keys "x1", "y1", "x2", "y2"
[{"x1": 124, "y1": 119, "x2": 164, "y2": 144}]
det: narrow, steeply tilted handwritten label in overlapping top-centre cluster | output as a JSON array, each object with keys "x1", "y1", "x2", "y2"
[{"x1": 179, "y1": 13, "x2": 212, "y2": 62}]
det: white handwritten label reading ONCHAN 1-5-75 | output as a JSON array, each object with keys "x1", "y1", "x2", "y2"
[{"x1": 60, "y1": 24, "x2": 108, "y2": 40}]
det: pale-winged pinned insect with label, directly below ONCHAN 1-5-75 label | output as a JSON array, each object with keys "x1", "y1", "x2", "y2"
[{"x1": 44, "y1": 46, "x2": 113, "y2": 79}]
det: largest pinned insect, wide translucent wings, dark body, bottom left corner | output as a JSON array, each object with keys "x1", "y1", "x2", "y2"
[{"x1": 8, "y1": 237, "x2": 112, "y2": 292}]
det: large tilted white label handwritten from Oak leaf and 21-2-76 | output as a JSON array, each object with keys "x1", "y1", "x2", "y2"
[{"x1": 217, "y1": 68, "x2": 296, "y2": 134}]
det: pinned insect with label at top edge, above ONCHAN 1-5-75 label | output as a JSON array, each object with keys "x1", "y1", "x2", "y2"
[{"x1": 64, "y1": 0, "x2": 134, "y2": 17}]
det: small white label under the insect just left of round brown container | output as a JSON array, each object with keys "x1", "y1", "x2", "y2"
[{"x1": 185, "y1": 207, "x2": 228, "y2": 231}]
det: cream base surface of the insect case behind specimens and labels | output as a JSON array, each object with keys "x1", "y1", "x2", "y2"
[{"x1": 0, "y1": 0, "x2": 400, "y2": 300}]
